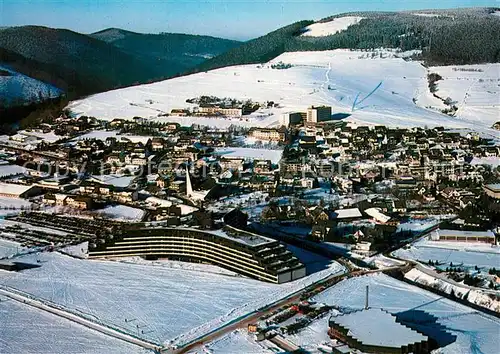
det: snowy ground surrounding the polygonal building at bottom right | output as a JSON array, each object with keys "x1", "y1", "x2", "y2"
[{"x1": 289, "y1": 274, "x2": 500, "y2": 354}]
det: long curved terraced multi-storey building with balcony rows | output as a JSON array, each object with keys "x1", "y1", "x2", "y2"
[{"x1": 89, "y1": 225, "x2": 306, "y2": 283}]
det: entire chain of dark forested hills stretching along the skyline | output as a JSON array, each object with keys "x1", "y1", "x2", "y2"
[{"x1": 0, "y1": 7, "x2": 500, "y2": 125}]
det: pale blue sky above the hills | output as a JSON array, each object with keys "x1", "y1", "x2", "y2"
[{"x1": 0, "y1": 0, "x2": 500, "y2": 40}]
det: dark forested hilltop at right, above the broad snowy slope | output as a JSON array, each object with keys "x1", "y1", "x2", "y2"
[{"x1": 195, "y1": 8, "x2": 500, "y2": 71}]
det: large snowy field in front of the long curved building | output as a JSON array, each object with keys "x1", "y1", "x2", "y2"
[{"x1": 0, "y1": 253, "x2": 343, "y2": 343}]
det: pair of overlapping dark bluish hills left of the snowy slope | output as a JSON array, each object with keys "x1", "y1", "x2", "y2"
[{"x1": 0, "y1": 26, "x2": 240, "y2": 105}]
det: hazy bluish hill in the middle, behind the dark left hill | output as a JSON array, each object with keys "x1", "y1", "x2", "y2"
[{"x1": 91, "y1": 28, "x2": 241, "y2": 76}]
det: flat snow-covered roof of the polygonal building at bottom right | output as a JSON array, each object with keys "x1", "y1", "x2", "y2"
[{"x1": 330, "y1": 309, "x2": 428, "y2": 348}]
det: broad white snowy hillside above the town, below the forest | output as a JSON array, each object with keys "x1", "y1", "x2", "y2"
[{"x1": 69, "y1": 50, "x2": 498, "y2": 135}]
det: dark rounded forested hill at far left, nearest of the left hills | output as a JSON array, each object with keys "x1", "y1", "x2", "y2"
[{"x1": 0, "y1": 26, "x2": 162, "y2": 96}]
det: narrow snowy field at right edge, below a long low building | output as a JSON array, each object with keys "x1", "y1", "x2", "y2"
[{"x1": 394, "y1": 240, "x2": 500, "y2": 268}]
